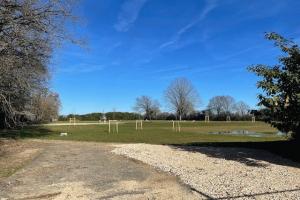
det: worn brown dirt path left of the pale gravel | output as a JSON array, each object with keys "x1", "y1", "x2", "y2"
[{"x1": 0, "y1": 141, "x2": 200, "y2": 200}]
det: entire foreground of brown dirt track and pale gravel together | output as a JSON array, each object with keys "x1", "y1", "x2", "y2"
[{"x1": 0, "y1": 140, "x2": 300, "y2": 200}]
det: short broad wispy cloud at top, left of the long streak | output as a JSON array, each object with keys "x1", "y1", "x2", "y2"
[{"x1": 114, "y1": 0, "x2": 147, "y2": 32}]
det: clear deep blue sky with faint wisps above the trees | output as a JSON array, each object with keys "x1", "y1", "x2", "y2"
[{"x1": 50, "y1": 0, "x2": 300, "y2": 114}]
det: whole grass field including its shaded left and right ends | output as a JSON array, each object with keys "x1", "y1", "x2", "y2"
[{"x1": 0, "y1": 121, "x2": 300, "y2": 162}]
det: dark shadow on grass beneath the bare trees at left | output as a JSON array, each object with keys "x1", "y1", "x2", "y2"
[{"x1": 0, "y1": 126, "x2": 54, "y2": 139}]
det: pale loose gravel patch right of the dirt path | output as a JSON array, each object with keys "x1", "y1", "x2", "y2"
[{"x1": 113, "y1": 144, "x2": 300, "y2": 200}]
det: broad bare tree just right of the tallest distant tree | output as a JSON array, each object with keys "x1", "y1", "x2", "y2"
[{"x1": 207, "y1": 96, "x2": 235, "y2": 116}]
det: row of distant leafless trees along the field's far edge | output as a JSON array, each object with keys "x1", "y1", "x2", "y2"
[{"x1": 134, "y1": 78, "x2": 253, "y2": 120}]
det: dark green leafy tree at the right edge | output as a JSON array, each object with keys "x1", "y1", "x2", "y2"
[{"x1": 249, "y1": 32, "x2": 300, "y2": 141}]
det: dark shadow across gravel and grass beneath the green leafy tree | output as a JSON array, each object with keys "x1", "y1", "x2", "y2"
[{"x1": 172, "y1": 141, "x2": 300, "y2": 168}]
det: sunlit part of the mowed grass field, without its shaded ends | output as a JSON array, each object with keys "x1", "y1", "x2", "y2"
[{"x1": 20, "y1": 121, "x2": 285, "y2": 144}]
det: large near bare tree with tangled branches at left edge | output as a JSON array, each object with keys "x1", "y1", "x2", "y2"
[{"x1": 0, "y1": 0, "x2": 78, "y2": 128}]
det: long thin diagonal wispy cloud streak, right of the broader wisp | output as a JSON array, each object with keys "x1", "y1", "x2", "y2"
[{"x1": 159, "y1": 0, "x2": 217, "y2": 49}]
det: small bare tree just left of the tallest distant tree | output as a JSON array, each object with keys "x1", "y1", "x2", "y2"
[{"x1": 134, "y1": 96, "x2": 160, "y2": 120}]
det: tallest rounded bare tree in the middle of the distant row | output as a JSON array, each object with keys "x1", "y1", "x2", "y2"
[{"x1": 165, "y1": 78, "x2": 199, "y2": 120}]
